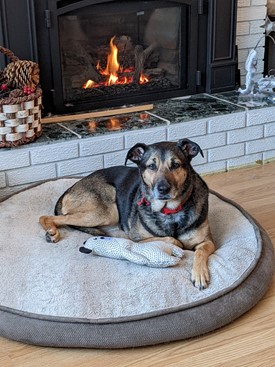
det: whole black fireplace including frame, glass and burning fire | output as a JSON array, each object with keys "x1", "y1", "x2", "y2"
[{"x1": 0, "y1": 0, "x2": 237, "y2": 113}]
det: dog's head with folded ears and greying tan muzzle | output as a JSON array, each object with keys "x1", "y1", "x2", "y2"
[{"x1": 125, "y1": 139, "x2": 203, "y2": 201}]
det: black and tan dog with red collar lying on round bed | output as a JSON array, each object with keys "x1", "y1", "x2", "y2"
[{"x1": 39, "y1": 139, "x2": 215, "y2": 290}]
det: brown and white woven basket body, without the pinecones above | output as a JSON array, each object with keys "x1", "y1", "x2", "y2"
[{"x1": 0, "y1": 89, "x2": 42, "y2": 148}]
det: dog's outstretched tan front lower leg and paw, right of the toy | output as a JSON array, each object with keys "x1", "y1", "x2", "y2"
[{"x1": 192, "y1": 240, "x2": 215, "y2": 290}]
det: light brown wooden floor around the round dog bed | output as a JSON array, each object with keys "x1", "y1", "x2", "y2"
[{"x1": 0, "y1": 163, "x2": 275, "y2": 367}]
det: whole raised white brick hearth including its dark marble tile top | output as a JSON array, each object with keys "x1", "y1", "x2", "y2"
[{"x1": 0, "y1": 91, "x2": 275, "y2": 198}]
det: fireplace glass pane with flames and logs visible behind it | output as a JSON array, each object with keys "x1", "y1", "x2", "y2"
[{"x1": 58, "y1": 1, "x2": 191, "y2": 106}]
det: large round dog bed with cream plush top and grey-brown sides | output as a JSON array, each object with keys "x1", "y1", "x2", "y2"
[{"x1": 0, "y1": 178, "x2": 274, "y2": 348}]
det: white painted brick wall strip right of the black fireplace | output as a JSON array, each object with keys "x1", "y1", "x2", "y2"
[{"x1": 236, "y1": 0, "x2": 267, "y2": 85}]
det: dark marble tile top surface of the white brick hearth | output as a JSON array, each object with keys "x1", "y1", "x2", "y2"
[{"x1": 37, "y1": 92, "x2": 247, "y2": 144}]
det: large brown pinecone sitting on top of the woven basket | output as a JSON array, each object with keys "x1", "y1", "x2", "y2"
[{"x1": 3, "y1": 60, "x2": 39, "y2": 88}]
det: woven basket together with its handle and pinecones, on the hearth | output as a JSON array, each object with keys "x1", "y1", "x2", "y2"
[{"x1": 0, "y1": 47, "x2": 42, "y2": 148}]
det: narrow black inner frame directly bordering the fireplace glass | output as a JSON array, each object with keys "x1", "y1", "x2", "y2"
[{"x1": 48, "y1": 0, "x2": 201, "y2": 112}]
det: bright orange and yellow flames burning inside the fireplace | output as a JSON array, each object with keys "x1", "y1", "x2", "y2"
[{"x1": 82, "y1": 36, "x2": 149, "y2": 89}]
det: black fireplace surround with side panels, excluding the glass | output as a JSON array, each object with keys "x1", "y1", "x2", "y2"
[{"x1": 0, "y1": 0, "x2": 238, "y2": 113}]
